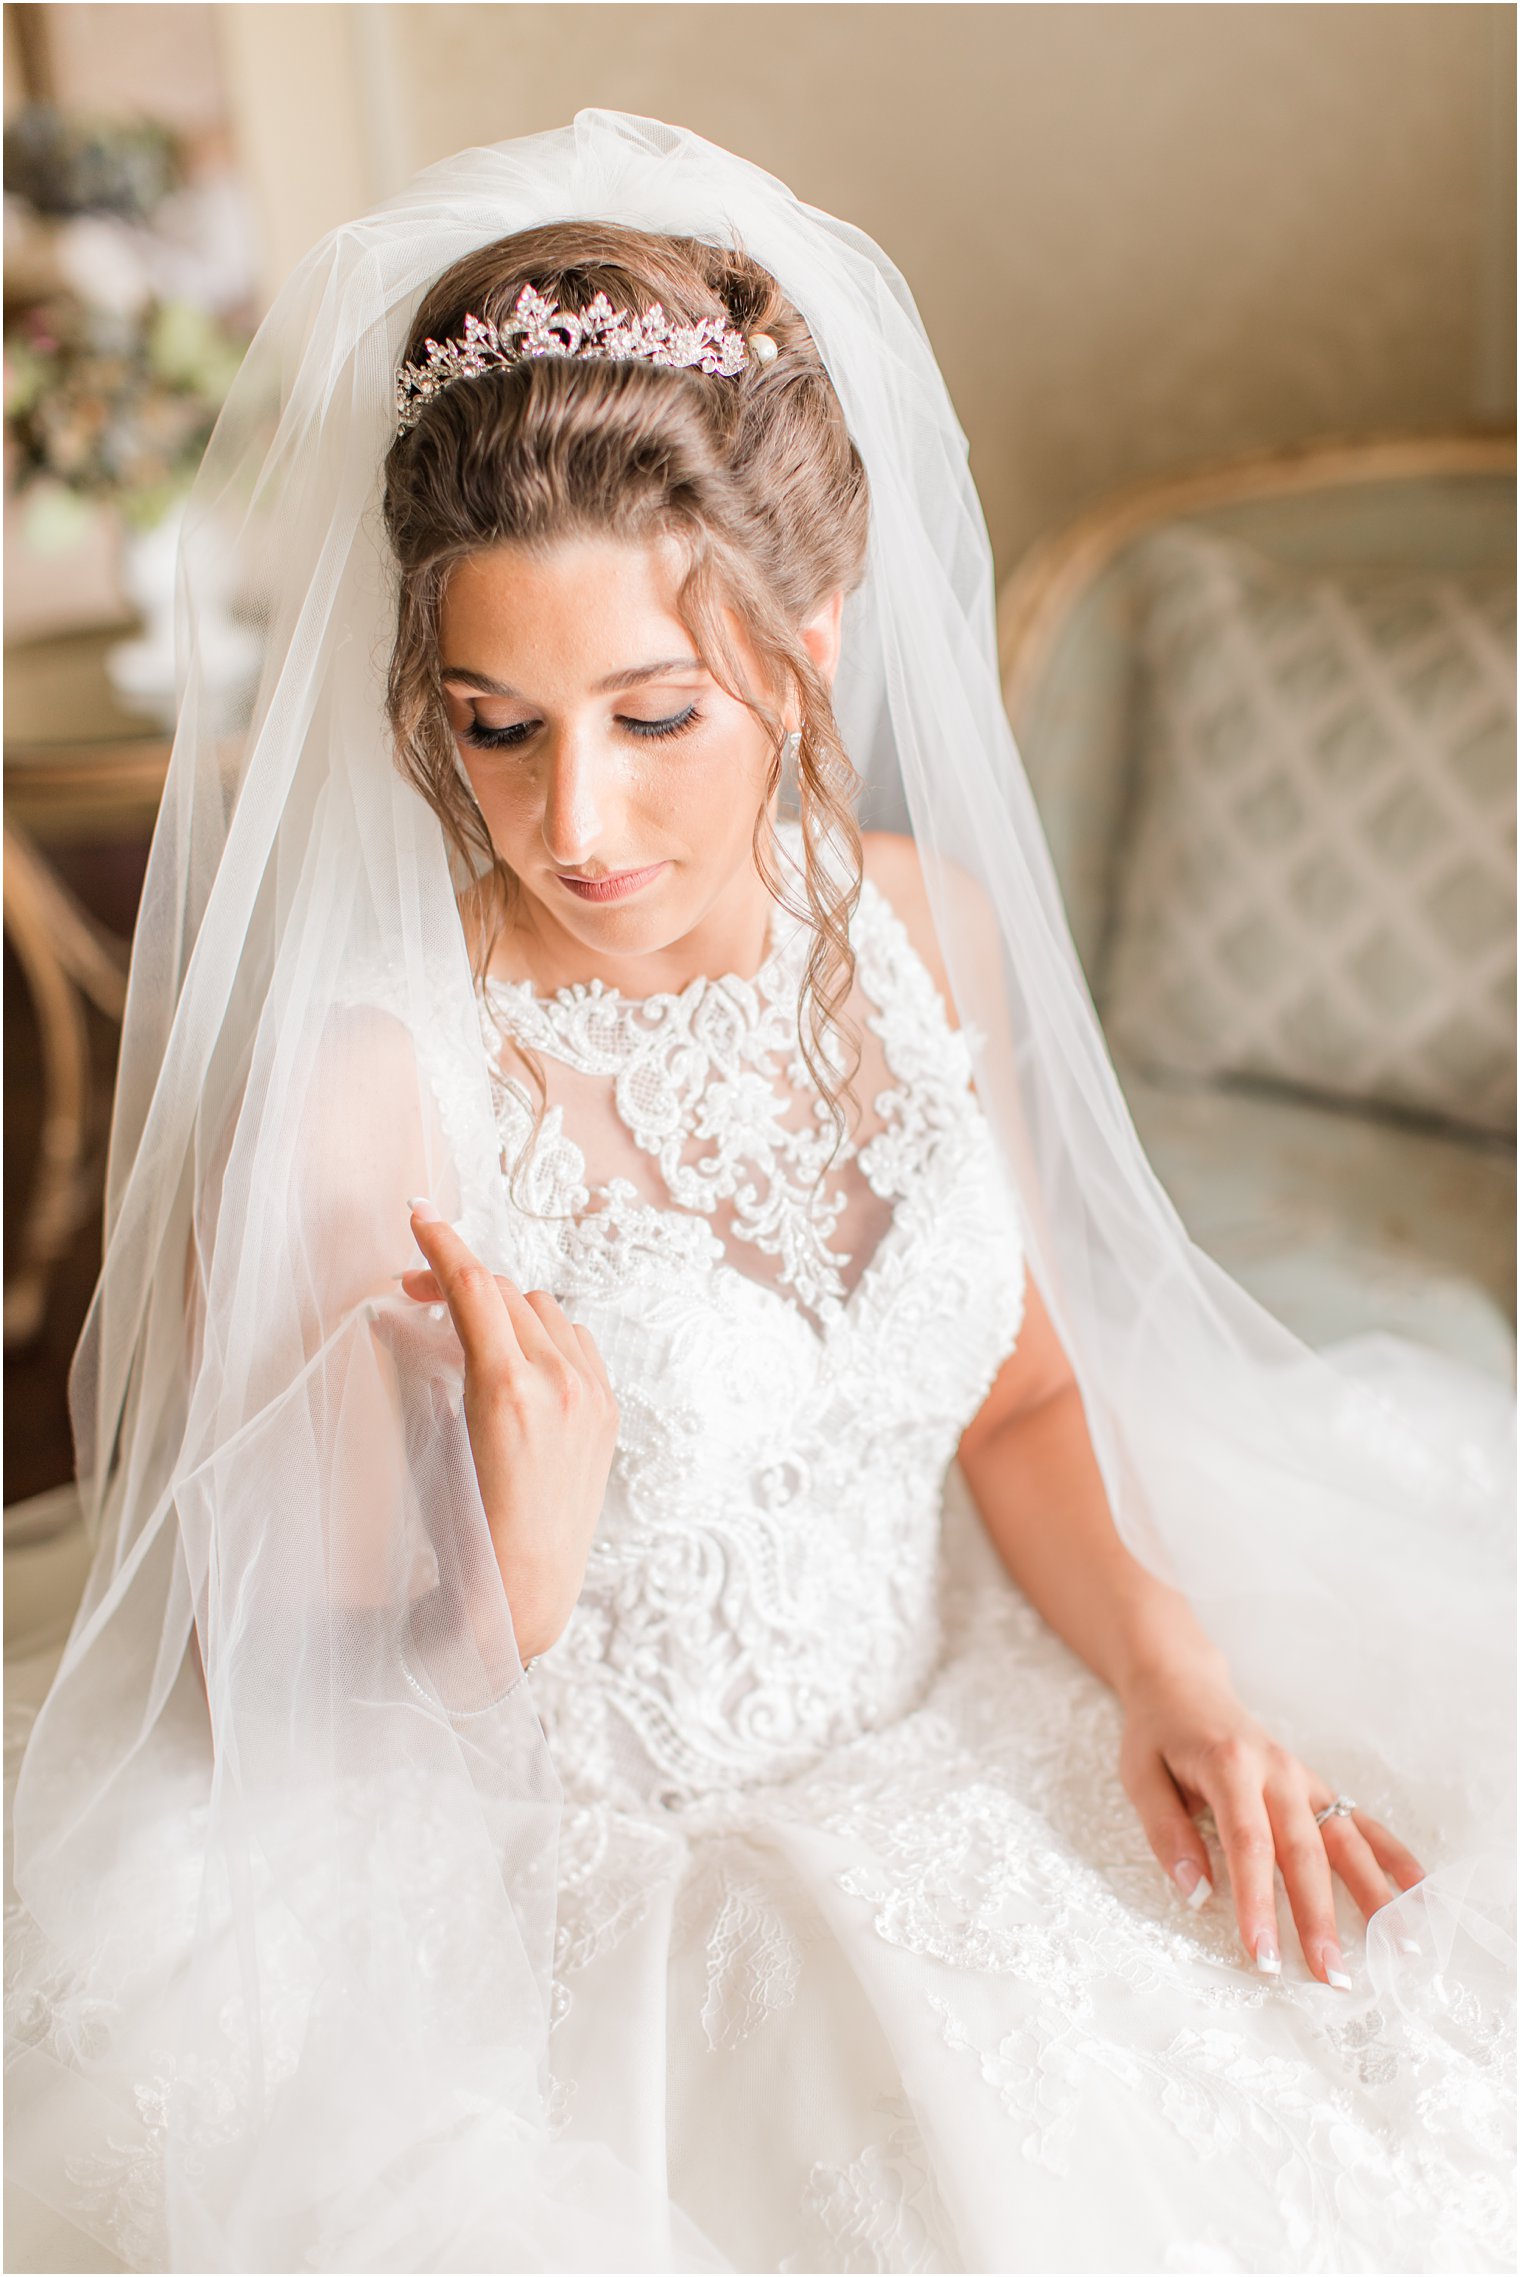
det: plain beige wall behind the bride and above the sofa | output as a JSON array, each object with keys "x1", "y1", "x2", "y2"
[{"x1": 216, "y1": 0, "x2": 1515, "y2": 569}]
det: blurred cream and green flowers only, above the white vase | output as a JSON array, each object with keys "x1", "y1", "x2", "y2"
[{"x1": 5, "y1": 105, "x2": 250, "y2": 553}]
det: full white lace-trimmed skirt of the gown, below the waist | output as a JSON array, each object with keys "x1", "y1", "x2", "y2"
[{"x1": 551, "y1": 1439, "x2": 1515, "y2": 2272}]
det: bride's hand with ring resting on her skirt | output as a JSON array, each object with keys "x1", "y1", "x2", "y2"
[{"x1": 1120, "y1": 1667, "x2": 1424, "y2": 1988}]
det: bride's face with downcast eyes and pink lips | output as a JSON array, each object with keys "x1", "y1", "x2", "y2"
[{"x1": 441, "y1": 537, "x2": 842, "y2": 993}]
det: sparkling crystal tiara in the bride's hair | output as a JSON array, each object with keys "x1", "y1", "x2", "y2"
[{"x1": 396, "y1": 285, "x2": 776, "y2": 435}]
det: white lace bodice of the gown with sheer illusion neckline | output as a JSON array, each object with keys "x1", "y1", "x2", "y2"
[{"x1": 482, "y1": 824, "x2": 1024, "y2": 1803}]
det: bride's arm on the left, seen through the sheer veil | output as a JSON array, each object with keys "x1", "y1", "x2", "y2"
[{"x1": 182, "y1": 1004, "x2": 548, "y2": 1712}]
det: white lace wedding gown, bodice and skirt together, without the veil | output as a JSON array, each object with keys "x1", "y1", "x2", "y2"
[{"x1": 5, "y1": 824, "x2": 1515, "y2": 2272}]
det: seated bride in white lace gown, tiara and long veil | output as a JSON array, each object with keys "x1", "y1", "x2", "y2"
[{"x1": 7, "y1": 112, "x2": 1513, "y2": 2270}]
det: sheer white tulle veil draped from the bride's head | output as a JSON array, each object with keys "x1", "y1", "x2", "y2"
[{"x1": 7, "y1": 109, "x2": 1513, "y2": 2270}]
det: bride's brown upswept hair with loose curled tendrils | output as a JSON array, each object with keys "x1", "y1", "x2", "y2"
[{"x1": 385, "y1": 221, "x2": 869, "y2": 1220}]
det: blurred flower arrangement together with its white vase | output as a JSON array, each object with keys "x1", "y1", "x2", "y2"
[{"x1": 5, "y1": 102, "x2": 257, "y2": 726}]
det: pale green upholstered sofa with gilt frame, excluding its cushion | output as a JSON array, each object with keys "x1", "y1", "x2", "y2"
[{"x1": 999, "y1": 435, "x2": 1515, "y2": 1380}]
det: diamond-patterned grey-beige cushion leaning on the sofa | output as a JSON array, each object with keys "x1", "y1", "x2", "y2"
[{"x1": 1099, "y1": 528, "x2": 1515, "y2": 1132}]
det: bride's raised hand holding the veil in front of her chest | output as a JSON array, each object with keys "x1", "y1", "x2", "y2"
[{"x1": 400, "y1": 1200, "x2": 619, "y2": 1660}]
